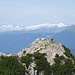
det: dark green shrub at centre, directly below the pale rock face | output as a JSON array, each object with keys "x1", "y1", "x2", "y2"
[{"x1": 34, "y1": 51, "x2": 51, "y2": 75}]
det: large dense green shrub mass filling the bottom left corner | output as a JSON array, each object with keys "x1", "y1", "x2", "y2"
[{"x1": 0, "y1": 56, "x2": 26, "y2": 75}]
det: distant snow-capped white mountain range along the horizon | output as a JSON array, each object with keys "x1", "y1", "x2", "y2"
[{"x1": 0, "y1": 23, "x2": 68, "y2": 32}]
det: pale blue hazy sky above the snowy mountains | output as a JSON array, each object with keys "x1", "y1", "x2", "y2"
[{"x1": 0, "y1": 0, "x2": 75, "y2": 26}]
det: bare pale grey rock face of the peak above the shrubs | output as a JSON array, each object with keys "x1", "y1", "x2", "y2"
[{"x1": 17, "y1": 38, "x2": 66, "y2": 64}]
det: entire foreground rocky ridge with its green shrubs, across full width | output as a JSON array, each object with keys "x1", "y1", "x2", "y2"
[{"x1": 0, "y1": 38, "x2": 75, "y2": 75}]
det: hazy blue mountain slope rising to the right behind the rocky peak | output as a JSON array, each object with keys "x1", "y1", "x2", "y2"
[{"x1": 53, "y1": 25, "x2": 75, "y2": 54}]
